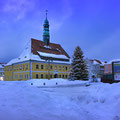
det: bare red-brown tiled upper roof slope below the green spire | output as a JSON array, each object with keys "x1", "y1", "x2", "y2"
[{"x1": 31, "y1": 38, "x2": 70, "y2": 58}]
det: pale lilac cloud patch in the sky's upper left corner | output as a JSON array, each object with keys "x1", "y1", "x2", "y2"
[{"x1": 3, "y1": 0, "x2": 35, "y2": 20}]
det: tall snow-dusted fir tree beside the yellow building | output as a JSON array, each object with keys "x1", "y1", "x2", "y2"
[{"x1": 69, "y1": 46, "x2": 88, "y2": 80}]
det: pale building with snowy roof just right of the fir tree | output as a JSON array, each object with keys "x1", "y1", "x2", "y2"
[{"x1": 85, "y1": 58, "x2": 104, "y2": 78}]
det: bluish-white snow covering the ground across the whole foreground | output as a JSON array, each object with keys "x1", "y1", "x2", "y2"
[{"x1": 0, "y1": 79, "x2": 120, "y2": 120}]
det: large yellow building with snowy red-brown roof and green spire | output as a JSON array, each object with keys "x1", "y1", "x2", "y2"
[{"x1": 4, "y1": 11, "x2": 70, "y2": 81}]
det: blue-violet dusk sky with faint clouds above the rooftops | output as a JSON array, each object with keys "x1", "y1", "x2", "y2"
[{"x1": 0, "y1": 0, "x2": 120, "y2": 63}]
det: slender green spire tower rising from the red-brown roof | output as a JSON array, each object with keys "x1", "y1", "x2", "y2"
[{"x1": 43, "y1": 10, "x2": 50, "y2": 46}]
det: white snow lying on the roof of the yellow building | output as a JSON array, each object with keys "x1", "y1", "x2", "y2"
[{"x1": 6, "y1": 40, "x2": 70, "y2": 66}]
